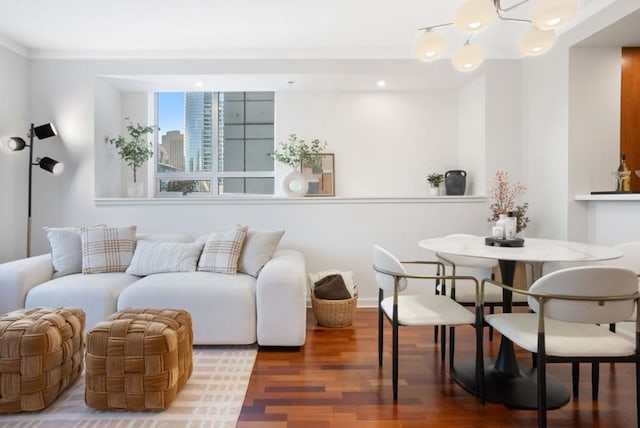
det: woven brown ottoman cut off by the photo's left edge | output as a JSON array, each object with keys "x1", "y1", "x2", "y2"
[{"x1": 0, "y1": 308, "x2": 85, "y2": 413}]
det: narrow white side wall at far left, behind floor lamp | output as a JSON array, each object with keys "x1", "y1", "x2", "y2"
[{"x1": 0, "y1": 46, "x2": 30, "y2": 262}]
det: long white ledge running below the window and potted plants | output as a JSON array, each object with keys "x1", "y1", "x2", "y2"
[{"x1": 94, "y1": 195, "x2": 487, "y2": 206}]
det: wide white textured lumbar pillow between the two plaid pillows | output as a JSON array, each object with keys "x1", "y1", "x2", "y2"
[{"x1": 126, "y1": 240, "x2": 202, "y2": 276}]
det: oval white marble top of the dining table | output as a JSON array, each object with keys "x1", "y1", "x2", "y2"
[{"x1": 418, "y1": 235, "x2": 623, "y2": 262}]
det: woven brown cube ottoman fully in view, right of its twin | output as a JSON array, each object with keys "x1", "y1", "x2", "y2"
[{"x1": 85, "y1": 308, "x2": 193, "y2": 410}]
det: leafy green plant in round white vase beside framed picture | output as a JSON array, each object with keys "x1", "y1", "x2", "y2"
[{"x1": 268, "y1": 134, "x2": 327, "y2": 196}]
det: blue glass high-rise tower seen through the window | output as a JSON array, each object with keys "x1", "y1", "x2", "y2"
[{"x1": 185, "y1": 92, "x2": 214, "y2": 172}]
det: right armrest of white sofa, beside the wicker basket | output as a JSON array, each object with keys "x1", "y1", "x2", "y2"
[{"x1": 256, "y1": 250, "x2": 307, "y2": 346}]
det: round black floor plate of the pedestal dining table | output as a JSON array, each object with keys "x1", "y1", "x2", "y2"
[{"x1": 453, "y1": 358, "x2": 570, "y2": 410}]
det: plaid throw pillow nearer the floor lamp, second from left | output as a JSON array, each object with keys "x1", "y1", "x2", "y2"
[{"x1": 80, "y1": 226, "x2": 136, "y2": 273}]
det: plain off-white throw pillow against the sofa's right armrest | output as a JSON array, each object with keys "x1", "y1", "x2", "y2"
[{"x1": 238, "y1": 230, "x2": 284, "y2": 278}]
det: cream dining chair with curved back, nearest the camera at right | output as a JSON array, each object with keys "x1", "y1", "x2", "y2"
[{"x1": 478, "y1": 266, "x2": 640, "y2": 427}]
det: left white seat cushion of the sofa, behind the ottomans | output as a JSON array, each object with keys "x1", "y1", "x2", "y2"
[{"x1": 24, "y1": 273, "x2": 140, "y2": 329}]
